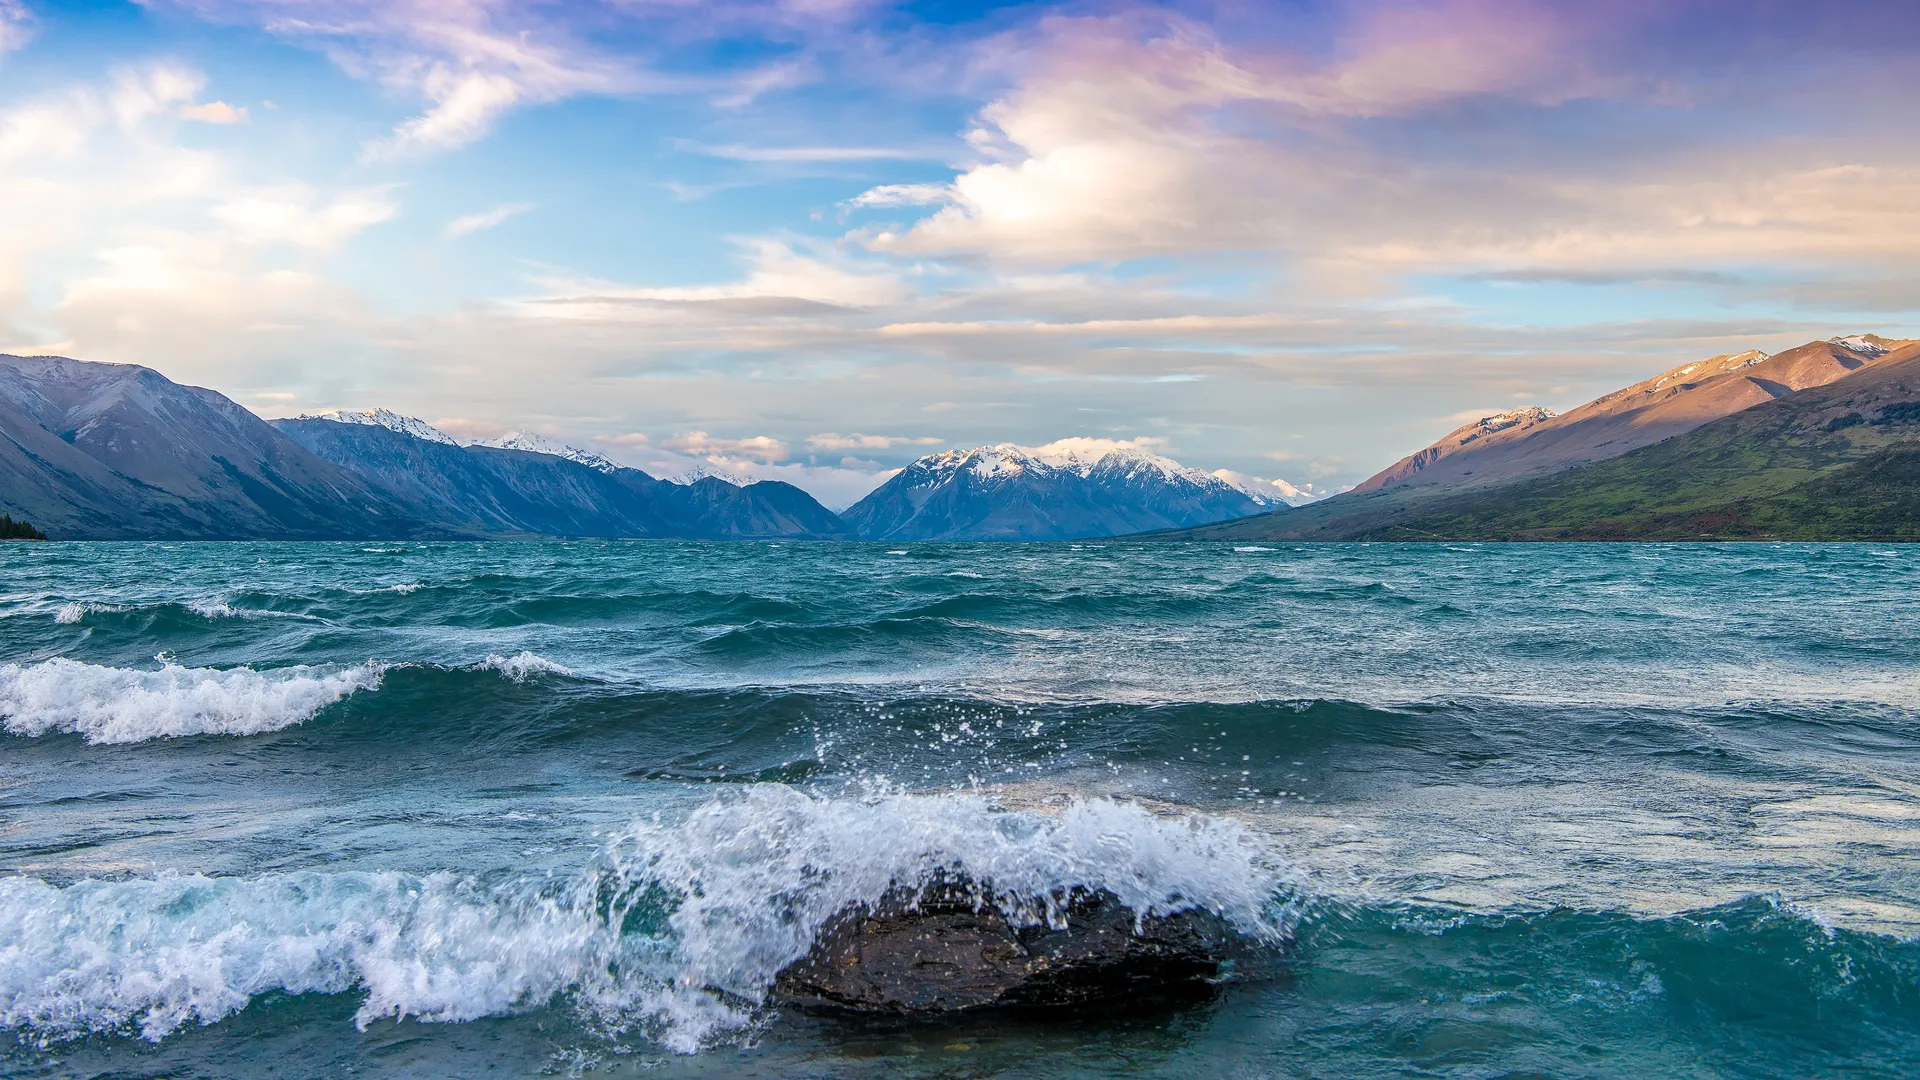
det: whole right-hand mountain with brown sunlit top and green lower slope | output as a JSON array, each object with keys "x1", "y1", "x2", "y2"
[{"x1": 1156, "y1": 334, "x2": 1920, "y2": 540}]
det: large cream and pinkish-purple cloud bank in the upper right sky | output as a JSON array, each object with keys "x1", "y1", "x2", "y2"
[{"x1": 867, "y1": 0, "x2": 1920, "y2": 274}]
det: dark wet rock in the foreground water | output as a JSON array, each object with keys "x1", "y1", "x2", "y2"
[{"x1": 774, "y1": 882, "x2": 1231, "y2": 1015}]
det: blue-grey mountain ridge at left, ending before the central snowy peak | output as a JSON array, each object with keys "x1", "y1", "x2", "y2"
[{"x1": 0, "y1": 356, "x2": 851, "y2": 540}]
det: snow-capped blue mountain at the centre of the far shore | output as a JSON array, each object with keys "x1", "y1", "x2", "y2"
[{"x1": 841, "y1": 440, "x2": 1269, "y2": 540}]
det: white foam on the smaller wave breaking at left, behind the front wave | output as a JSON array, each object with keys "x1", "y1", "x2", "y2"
[{"x1": 0, "y1": 657, "x2": 386, "y2": 744}]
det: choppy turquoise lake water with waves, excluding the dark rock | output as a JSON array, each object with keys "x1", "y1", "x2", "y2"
[{"x1": 0, "y1": 542, "x2": 1920, "y2": 1078}]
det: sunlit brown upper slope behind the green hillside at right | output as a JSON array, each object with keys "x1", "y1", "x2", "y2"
[{"x1": 1354, "y1": 334, "x2": 1920, "y2": 492}]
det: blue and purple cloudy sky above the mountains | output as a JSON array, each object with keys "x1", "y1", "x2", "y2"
[{"x1": 0, "y1": 0, "x2": 1920, "y2": 505}]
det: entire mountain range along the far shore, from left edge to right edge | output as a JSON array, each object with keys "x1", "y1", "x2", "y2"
[{"x1": 0, "y1": 334, "x2": 1920, "y2": 542}]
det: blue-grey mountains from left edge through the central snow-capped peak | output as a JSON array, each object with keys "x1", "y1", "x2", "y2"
[{"x1": 0, "y1": 356, "x2": 1311, "y2": 540}]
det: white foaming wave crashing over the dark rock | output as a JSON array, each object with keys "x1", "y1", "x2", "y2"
[{"x1": 0, "y1": 784, "x2": 1298, "y2": 1053}]
